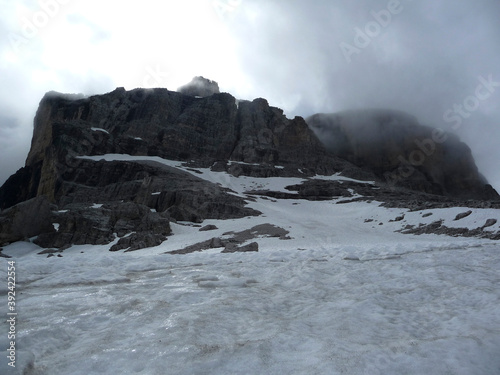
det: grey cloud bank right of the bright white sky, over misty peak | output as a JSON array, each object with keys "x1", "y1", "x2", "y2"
[{"x1": 226, "y1": 0, "x2": 500, "y2": 188}]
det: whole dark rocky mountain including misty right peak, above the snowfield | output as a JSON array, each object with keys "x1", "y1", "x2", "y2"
[{"x1": 0, "y1": 83, "x2": 498, "y2": 250}]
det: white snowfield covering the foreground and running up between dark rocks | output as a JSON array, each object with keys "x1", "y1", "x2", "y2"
[{"x1": 0, "y1": 156, "x2": 500, "y2": 375}]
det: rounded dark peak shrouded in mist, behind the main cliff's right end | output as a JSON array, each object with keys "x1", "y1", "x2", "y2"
[{"x1": 307, "y1": 110, "x2": 499, "y2": 199}]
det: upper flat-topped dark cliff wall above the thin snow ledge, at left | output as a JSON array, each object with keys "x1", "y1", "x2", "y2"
[{"x1": 0, "y1": 88, "x2": 348, "y2": 209}]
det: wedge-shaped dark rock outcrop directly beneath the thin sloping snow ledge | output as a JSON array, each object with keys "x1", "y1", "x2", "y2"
[{"x1": 56, "y1": 158, "x2": 260, "y2": 222}]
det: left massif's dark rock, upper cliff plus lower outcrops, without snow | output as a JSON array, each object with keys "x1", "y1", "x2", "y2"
[{"x1": 0, "y1": 85, "x2": 352, "y2": 250}]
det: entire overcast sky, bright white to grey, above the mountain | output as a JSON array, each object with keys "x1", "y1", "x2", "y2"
[{"x1": 0, "y1": 0, "x2": 500, "y2": 191}]
